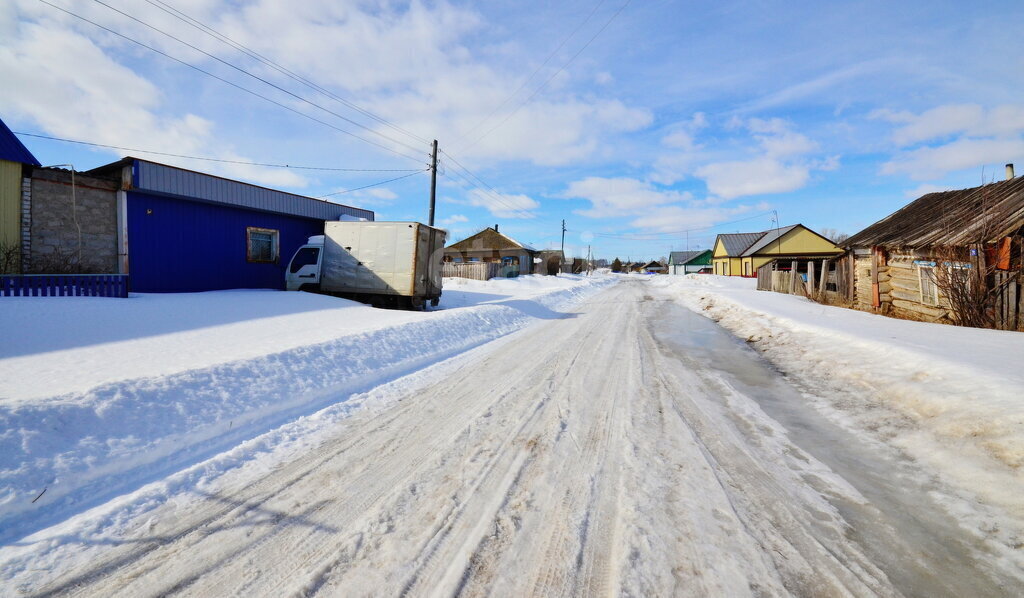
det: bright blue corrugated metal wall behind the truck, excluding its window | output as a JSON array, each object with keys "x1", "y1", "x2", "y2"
[{"x1": 128, "y1": 191, "x2": 324, "y2": 293}]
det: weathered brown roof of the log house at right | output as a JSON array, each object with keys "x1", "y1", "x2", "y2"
[{"x1": 843, "y1": 177, "x2": 1024, "y2": 247}]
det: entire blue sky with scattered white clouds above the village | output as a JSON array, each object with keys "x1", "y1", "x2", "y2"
[{"x1": 0, "y1": 0, "x2": 1024, "y2": 260}]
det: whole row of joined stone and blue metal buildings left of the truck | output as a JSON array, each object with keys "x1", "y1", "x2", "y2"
[{"x1": 0, "y1": 118, "x2": 374, "y2": 293}]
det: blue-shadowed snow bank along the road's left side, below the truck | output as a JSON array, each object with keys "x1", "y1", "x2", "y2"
[{"x1": 0, "y1": 275, "x2": 616, "y2": 541}]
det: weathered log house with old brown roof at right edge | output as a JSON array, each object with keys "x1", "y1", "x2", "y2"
[{"x1": 845, "y1": 165, "x2": 1024, "y2": 329}]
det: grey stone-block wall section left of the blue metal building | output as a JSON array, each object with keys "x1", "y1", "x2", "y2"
[{"x1": 25, "y1": 169, "x2": 118, "y2": 273}]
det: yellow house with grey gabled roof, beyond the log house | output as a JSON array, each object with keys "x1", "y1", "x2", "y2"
[{"x1": 714, "y1": 224, "x2": 843, "y2": 276}]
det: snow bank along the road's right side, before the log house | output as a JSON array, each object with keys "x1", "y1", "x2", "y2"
[{"x1": 650, "y1": 274, "x2": 1024, "y2": 516}]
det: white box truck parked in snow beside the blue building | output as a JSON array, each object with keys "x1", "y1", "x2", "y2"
[{"x1": 285, "y1": 221, "x2": 445, "y2": 309}]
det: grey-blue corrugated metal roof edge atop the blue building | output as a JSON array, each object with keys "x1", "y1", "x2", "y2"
[{"x1": 83, "y1": 157, "x2": 374, "y2": 220}]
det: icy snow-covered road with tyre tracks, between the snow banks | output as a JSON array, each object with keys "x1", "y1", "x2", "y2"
[{"x1": 12, "y1": 280, "x2": 1021, "y2": 597}]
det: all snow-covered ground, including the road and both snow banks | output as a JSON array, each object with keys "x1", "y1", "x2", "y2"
[{"x1": 0, "y1": 275, "x2": 1024, "y2": 596}]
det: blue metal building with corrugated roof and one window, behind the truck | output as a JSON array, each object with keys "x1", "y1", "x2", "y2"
[{"x1": 87, "y1": 158, "x2": 374, "y2": 293}]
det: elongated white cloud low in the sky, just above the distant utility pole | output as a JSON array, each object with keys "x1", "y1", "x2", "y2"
[{"x1": 560, "y1": 176, "x2": 692, "y2": 218}]
